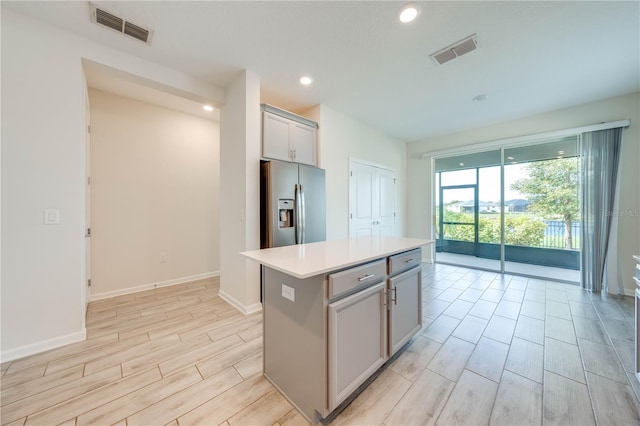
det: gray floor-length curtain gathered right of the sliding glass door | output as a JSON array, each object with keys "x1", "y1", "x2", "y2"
[{"x1": 580, "y1": 128, "x2": 622, "y2": 292}]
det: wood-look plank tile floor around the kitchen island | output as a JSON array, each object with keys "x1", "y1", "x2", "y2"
[{"x1": 0, "y1": 265, "x2": 640, "y2": 426}]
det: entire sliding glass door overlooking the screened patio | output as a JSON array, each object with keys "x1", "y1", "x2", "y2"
[{"x1": 435, "y1": 136, "x2": 580, "y2": 282}]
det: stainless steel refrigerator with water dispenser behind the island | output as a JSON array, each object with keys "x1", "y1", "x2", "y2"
[{"x1": 260, "y1": 160, "x2": 327, "y2": 248}]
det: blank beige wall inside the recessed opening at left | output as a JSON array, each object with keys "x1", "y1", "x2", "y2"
[{"x1": 89, "y1": 89, "x2": 220, "y2": 300}]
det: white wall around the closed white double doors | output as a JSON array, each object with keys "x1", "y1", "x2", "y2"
[{"x1": 303, "y1": 105, "x2": 407, "y2": 240}]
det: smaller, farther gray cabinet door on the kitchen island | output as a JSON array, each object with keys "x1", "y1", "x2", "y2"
[{"x1": 389, "y1": 266, "x2": 422, "y2": 356}]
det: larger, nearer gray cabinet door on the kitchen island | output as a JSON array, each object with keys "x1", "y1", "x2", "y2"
[{"x1": 328, "y1": 282, "x2": 387, "y2": 411}]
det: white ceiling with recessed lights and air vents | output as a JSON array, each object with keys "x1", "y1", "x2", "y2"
[{"x1": 2, "y1": 1, "x2": 640, "y2": 142}]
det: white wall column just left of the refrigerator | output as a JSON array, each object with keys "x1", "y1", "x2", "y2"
[{"x1": 220, "y1": 71, "x2": 262, "y2": 314}]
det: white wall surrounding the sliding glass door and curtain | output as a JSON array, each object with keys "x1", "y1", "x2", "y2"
[{"x1": 407, "y1": 93, "x2": 640, "y2": 294}]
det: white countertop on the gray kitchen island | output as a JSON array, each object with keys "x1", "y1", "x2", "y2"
[{"x1": 240, "y1": 237, "x2": 433, "y2": 279}]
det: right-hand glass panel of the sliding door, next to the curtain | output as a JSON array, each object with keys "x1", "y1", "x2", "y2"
[{"x1": 504, "y1": 136, "x2": 580, "y2": 281}]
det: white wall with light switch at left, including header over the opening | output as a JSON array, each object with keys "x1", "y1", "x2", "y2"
[{"x1": 0, "y1": 4, "x2": 225, "y2": 361}]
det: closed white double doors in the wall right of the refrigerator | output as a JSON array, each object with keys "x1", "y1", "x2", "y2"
[{"x1": 349, "y1": 161, "x2": 396, "y2": 237}]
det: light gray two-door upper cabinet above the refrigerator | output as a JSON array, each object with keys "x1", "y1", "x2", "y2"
[{"x1": 262, "y1": 104, "x2": 318, "y2": 166}]
